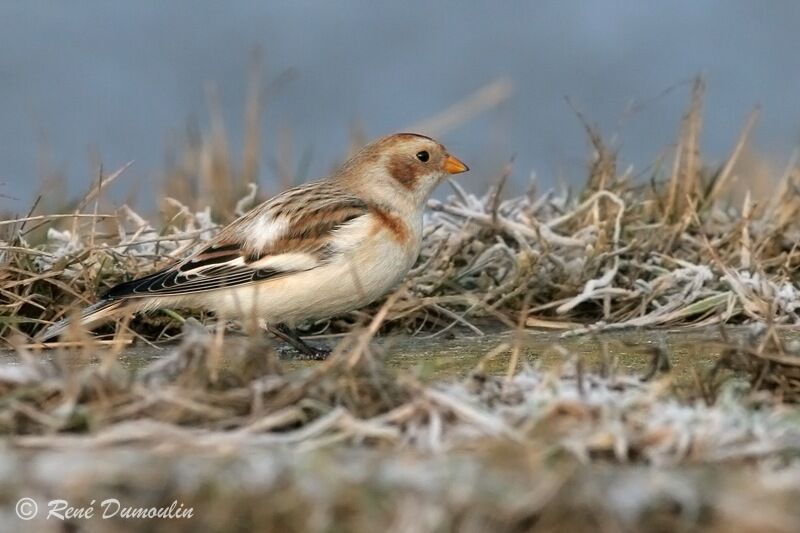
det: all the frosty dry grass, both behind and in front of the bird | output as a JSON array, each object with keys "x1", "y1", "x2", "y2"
[{"x1": 0, "y1": 77, "x2": 800, "y2": 531}]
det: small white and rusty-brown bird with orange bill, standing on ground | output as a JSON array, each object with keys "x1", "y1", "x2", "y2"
[{"x1": 37, "y1": 133, "x2": 469, "y2": 359}]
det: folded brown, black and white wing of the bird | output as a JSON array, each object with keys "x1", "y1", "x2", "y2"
[{"x1": 103, "y1": 183, "x2": 369, "y2": 300}]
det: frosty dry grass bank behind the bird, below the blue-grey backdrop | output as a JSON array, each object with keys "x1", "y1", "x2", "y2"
[{"x1": 0, "y1": 76, "x2": 800, "y2": 339}]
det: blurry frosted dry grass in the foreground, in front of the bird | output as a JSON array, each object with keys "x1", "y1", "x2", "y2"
[{"x1": 0, "y1": 323, "x2": 800, "y2": 532}]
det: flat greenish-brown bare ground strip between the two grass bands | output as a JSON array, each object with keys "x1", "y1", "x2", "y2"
[{"x1": 0, "y1": 326, "x2": 780, "y2": 383}]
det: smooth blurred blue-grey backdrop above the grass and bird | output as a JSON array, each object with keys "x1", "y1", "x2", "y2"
[{"x1": 0, "y1": 0, "x2": 800, "y2": 212}]
